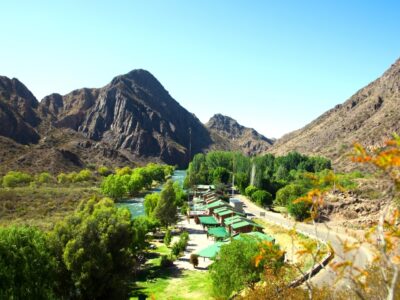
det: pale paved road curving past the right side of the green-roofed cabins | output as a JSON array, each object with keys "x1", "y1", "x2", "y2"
[{"x1": 235, "y1": 196, "x2": 373, "y2": 285}]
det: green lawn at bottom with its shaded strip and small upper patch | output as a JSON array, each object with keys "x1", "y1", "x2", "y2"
[{"x1": 131, "y1": 243, "x2": 212, "y2": 300}]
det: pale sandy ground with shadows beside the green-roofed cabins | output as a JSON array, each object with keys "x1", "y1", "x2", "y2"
[{"x1": 171, "y1": 219, "x2": 214, "y2": 270}]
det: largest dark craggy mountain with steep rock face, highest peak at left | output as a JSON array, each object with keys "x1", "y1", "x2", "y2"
[{"x1": 40, "y1": 70, "x2": 212, "y2": 166}]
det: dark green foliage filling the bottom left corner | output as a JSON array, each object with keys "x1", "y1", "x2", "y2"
[{"x1": 0, "y1": 227, "x2": 55, "y2": 299}]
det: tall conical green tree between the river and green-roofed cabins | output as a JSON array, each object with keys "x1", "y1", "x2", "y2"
[{"x1": 154, "y1": 180, "x2": 178, "y2": 227}]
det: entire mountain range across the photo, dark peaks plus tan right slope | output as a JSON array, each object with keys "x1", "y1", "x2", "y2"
[{"x1": 0, "y1": 60, "x2": 400, "y2": 173}]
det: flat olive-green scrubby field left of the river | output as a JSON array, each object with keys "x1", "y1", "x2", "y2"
[{"x1": 0, "y1": 183, "x2": 100, "y2": 230}]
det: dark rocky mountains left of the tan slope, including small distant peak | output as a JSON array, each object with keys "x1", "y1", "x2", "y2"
[{"x1": 0, "y1": 70, "x2": 272, "y2": 173}]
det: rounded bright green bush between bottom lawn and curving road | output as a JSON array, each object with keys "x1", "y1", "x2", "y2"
[{"x1": 210, "y1": 236, "x2": 264, "y2": 299}]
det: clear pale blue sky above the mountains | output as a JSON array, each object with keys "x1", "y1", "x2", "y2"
[{"x1": 0, "y1": 0, "x2": 400, "y2": 137}]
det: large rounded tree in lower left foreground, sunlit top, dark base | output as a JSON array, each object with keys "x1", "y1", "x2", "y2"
[{"x1": 51, "y1": 198, "x2": 134, "y2": 299}]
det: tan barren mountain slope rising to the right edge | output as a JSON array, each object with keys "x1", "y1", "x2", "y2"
[{"x1": 269, "y1": 59, "x2": 400, "y2": 169}]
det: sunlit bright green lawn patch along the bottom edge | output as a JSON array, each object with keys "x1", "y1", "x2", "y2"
[{"x1": 131, "y1": 270, "x2": 212, "y2": 300}]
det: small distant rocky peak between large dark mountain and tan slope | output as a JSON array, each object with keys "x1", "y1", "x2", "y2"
[{"x1": 206, "y1": 114, "x2": 273, "y2": 155}]
